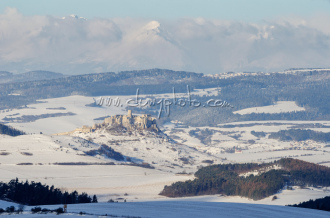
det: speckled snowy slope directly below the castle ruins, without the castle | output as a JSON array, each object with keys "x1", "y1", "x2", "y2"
[{"x1": 72, "y1": 129, "x2": 221, "y2": 173}]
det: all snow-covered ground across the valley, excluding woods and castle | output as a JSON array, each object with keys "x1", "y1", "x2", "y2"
[{"x1": 0, "y1": 80, "x2": 330, "y2": 217}]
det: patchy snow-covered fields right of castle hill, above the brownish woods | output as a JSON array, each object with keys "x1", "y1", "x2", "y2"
[{"x1": 165, "y1": 121, "x2": 330, "y2": 166}]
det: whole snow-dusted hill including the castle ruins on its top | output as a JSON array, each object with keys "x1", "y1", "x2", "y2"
[{"x1": 57, "y1": 111, "x2": 222, "y2": 173}]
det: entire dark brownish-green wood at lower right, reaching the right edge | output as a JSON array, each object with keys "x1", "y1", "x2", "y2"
[{"x1": 160, "y1": 158, "x2": 330, "y2": 200}]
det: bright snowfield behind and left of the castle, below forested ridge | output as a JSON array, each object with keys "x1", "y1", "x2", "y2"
[{"x1": 0, "y1": 96, "x2": 126, "y2": 134}]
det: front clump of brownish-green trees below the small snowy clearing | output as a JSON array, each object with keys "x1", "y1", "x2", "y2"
[{"x1": 160, "y1": 165, "x2": 285, "y2": 200}]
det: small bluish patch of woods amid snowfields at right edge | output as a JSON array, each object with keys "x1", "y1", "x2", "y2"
[{"x1": 269, "y1": 129, "x2": 330, "y2": 142}]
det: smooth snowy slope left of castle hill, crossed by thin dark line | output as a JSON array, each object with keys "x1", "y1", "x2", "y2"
[{"x1": 0, "y1": 135, "x2": 192, "y2": 200}]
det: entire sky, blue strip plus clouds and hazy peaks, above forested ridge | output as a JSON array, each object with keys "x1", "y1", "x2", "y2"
[{"x1": 0, "y1": 0, "x2": 330, "y2": 74}]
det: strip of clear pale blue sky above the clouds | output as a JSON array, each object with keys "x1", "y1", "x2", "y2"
[{"x1": 0, "y1": 0, "x2": 330, "y2": 22}]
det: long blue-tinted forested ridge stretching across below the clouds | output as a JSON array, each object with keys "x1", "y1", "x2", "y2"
[{"x1": 0, "y1": 68, "x2": 330, "y2": 126}]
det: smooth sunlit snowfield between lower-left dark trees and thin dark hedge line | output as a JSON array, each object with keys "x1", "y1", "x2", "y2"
[{"x1": 0, "y1": 165, "x2": 192, "y2": 201}]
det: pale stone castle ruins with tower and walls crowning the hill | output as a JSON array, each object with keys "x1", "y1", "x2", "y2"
[{"x1": 63, "y1": 110, "x2": 160, "y2": 134}]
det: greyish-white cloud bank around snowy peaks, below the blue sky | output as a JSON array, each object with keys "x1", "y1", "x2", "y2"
[{"x1": 0, "y1": 8, "x2": 330, "y2": 74}]
